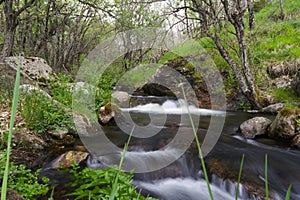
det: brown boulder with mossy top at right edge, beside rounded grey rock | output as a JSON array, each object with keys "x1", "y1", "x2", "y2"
[{"x1": 269, "y1": 107, "x2": 300, "y2": 139}]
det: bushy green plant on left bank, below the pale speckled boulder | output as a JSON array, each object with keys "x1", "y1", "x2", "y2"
[{"x1": 21, "y1": 91, "x2": 74, "y2": 133}]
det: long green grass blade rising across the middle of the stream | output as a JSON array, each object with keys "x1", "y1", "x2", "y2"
[{"x1": 181, "y1": 84, "x2": 214, "y2": 200}]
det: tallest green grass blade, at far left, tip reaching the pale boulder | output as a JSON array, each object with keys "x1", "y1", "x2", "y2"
[{"x1": 1, "y1": 57, "x2": 21, "y2": 200}]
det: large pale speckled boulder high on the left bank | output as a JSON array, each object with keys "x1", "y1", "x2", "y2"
[{"x1": 4, "y1": 56, "x2": 53, "y2": 82}]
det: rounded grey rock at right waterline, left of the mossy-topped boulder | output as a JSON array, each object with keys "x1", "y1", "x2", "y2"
[{"x1": 240, "y1": 117, "x2": 272, "y2": 138}]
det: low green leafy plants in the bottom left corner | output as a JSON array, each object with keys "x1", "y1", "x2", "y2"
[{"x1": 0, "y1": 151, "x2": 48, "y2": 199}]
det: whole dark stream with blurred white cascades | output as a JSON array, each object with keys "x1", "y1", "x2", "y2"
[{"x1": 46, "y1": 97, "x2": 300, "y2": 200}]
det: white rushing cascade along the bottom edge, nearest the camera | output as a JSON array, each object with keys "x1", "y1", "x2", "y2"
[{"x1": 133, "y1": 175, "x2": 260, "y2": 200}]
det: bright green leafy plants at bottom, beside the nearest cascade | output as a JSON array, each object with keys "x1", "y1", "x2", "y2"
[{"x1": 70, "y1": 165, "x2": 153, "y2": 200}]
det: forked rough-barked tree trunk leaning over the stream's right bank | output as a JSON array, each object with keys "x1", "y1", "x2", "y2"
[{"x1": 170, "y1": 0, "x2": 262, "y2": 108}]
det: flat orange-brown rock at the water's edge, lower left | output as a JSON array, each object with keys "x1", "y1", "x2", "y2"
[{"x1": 50, "y1": 151, "x2": 89, "y2": 169}]
